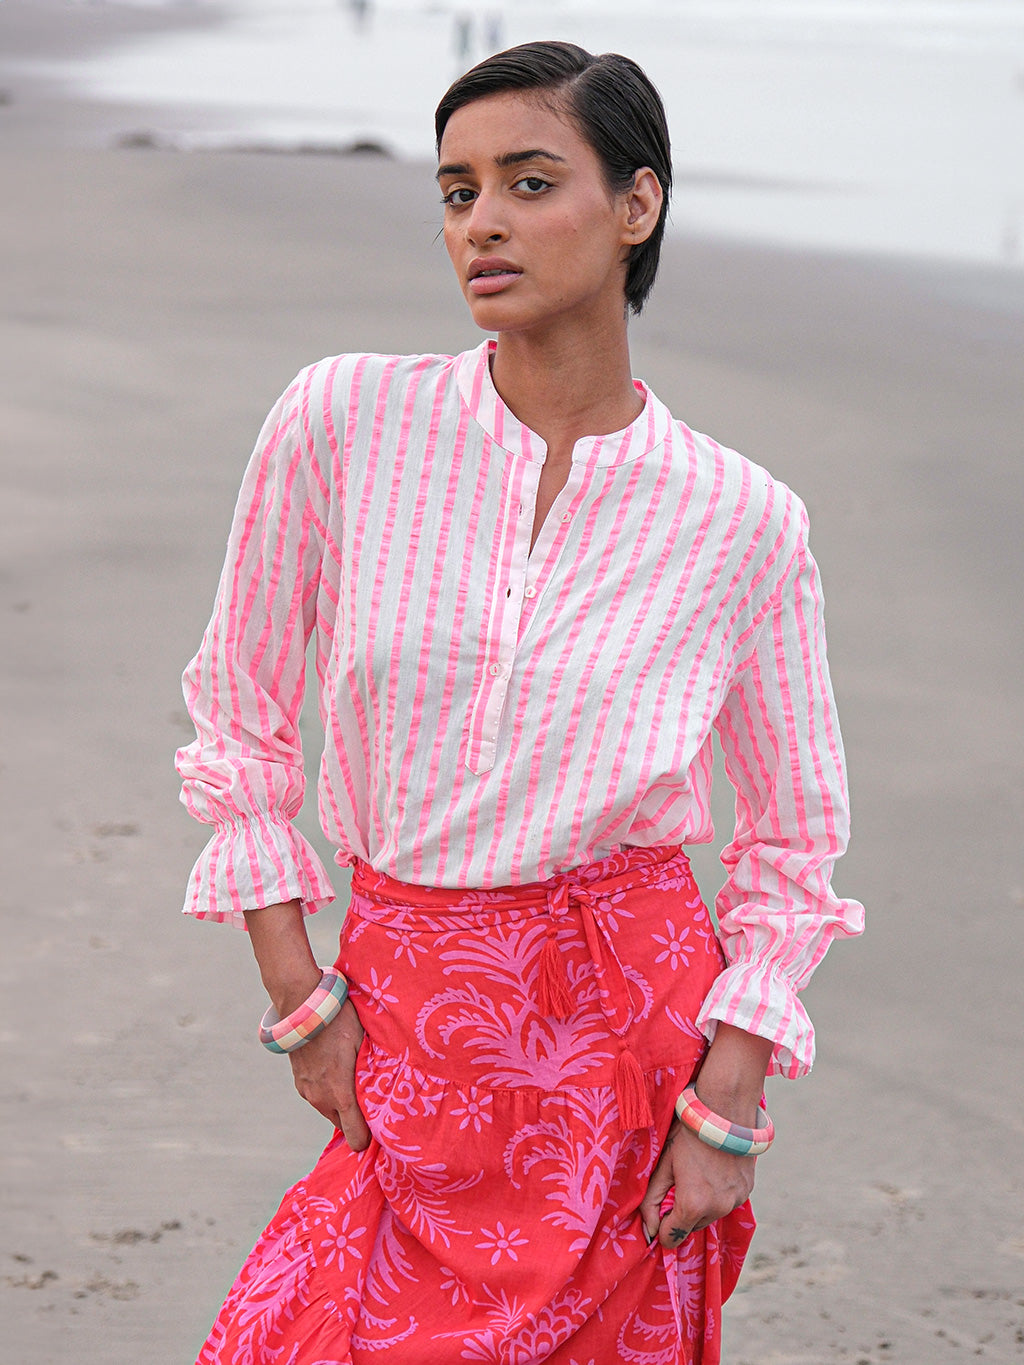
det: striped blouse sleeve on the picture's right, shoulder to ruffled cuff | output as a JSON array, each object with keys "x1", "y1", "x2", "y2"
[{"x1": 699, "y1": 506, "x2": 864, "y2": 1077}]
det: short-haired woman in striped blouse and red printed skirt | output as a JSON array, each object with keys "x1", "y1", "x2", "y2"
[{"x1": 179, "y1": 42, "x2": 862, "y2": 1365}]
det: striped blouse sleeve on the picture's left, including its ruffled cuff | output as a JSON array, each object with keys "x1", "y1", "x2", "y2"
[{"x1": 176, "y1": 371, "x2": 333, "y2": 927}]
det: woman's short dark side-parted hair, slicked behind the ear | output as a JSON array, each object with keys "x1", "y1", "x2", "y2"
[{"x1": 434, "y1": 42, "x2": 672, "y2": 313}]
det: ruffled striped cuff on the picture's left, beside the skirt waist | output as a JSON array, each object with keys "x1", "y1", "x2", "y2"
[{"x1": 184, "y1": 816, "x2": 335, "y2": 928}]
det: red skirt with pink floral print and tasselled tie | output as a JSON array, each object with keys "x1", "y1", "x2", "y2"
[{"x1": 197, "y1": 848, "x2": 754, "y2": 1365}]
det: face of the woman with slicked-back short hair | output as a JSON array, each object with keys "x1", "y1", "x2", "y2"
[{"x1": 437, "y1": 93, "x2": 638, "y2": 332}]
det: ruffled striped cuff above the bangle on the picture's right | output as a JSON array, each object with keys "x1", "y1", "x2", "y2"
[{"x1": 696, "y1": 962, "x2": 814, "y2": 1080}]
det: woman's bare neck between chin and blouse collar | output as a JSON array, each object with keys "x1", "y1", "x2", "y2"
[{"x1": 492, "y1": 312, "x2": 643, "y2": 452}]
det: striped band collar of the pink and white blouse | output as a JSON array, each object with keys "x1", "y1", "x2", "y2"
[{"x1": 455, "y1": 337, "x2": 672, "y2": 465}]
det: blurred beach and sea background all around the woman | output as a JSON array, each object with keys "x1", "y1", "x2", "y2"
[{"x1": 0, "y1": 0, "x2": 1024, "y2": 1365}]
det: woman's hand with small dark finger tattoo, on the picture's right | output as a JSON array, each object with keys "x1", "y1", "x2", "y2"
[{"x1": 640, "y1": 1119, "x2": 756, "y2": 1249}]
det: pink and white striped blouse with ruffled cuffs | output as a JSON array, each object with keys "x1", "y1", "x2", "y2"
[{"x1": 177, "y1": 343, "x2": 863, "y2": 1076}]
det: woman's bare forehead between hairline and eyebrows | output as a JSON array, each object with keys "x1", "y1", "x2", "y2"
[{"x1": 440, "y1": 90, "x2": 597, "y2": 165}]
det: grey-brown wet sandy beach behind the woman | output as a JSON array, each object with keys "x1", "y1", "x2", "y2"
[{"x1": 0, "y1": 3, "x2": 1024, "y2": 1365}]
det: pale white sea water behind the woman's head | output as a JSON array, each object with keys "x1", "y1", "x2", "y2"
[{"x1": 27, "y1": 0, "x2": 1024, "y2": 270}]
